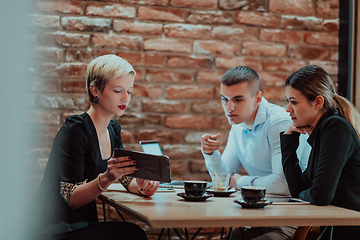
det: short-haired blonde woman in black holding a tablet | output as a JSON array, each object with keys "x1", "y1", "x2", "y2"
[{"x1": 31, "y1": 55, "x2": 159, "y2": 240}]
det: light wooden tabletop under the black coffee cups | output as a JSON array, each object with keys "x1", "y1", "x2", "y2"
[{"x1": 99, "y1": 185, "x2": 360, "y2": 228}]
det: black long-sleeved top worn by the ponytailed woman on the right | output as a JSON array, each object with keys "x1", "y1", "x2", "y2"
[{"x1": 280, "y1": 111, "x2": 360, "y2": 239}]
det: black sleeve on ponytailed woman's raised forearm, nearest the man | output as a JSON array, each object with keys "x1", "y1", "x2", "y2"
[{"x1": 280, "y1": 132, "x2": 311, "y2": 197}]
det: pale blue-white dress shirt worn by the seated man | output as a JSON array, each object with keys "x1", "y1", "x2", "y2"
[{"x1": 203, "y1": 98, "x2": 310, "y2": 195}]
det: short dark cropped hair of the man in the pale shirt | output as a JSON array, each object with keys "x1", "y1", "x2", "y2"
[{"x1": 221, "y1": 66, "x2": 261, "y2": 96}]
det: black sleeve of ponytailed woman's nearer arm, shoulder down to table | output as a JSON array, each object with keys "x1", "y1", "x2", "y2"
[{"x1": 299, "y1": 117, "x2": 352, "y2": 205}]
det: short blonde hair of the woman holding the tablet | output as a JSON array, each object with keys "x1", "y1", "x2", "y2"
[{"x1": 86, "y1": 54, "x2": 136, "y2": 103}]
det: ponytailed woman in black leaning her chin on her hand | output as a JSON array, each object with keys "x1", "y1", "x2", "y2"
[{"x1": 280, "y1": 65, "x2": 360, "y2": 240}]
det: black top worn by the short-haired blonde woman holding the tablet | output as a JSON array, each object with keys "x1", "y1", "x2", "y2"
[{"x1": 34, "y1": 113, "x2": 123, "y2": 236}]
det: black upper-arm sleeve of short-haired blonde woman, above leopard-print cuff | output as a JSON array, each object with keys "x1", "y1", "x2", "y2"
[{"x1": 54, "y1": 117, "x2": 89, "y2": 183}]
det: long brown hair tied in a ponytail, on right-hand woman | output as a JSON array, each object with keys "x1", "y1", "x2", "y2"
[{"x1": 285, "y1": 65, "x2": 360, "y2": 137}]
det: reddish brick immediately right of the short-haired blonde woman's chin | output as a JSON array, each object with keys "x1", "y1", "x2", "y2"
[{"x1": 118, "y1": 112, "x2": 162, "y2": 128}]
